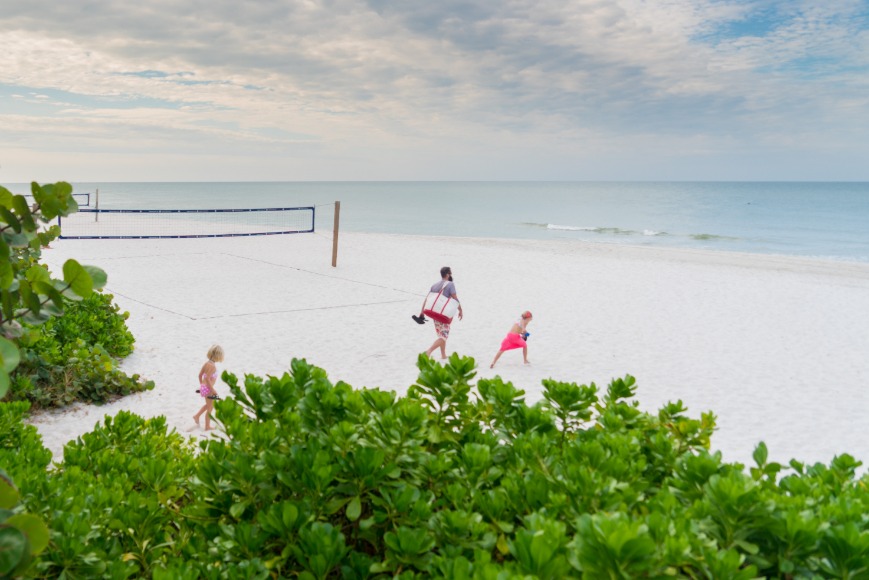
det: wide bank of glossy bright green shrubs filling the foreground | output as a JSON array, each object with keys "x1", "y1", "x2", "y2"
[{"x1": 0, "y1": 355, "x2": 869, "y2": 580}]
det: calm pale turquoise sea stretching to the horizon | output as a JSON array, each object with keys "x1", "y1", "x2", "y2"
[{"x1": 7, "y1": 182, "x2": 869, "y2": 262}]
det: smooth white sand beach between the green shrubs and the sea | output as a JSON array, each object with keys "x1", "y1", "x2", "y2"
[{"x1": 27, "y1": 233, "x2": 869, "y2": 472}]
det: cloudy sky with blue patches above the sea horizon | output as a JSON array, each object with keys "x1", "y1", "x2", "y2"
[{"x1": 0, "y1": 0, "x2": 869, "y2": 183}]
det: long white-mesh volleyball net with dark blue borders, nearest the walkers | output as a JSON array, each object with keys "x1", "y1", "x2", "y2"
[{"x1": 58, "y1": 206, "x2": 315, "y2": 240}]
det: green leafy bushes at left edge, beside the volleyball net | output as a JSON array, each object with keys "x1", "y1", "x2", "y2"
[{"x1": 0, "y1": 182, "x2": 153, "y2": 408}]
